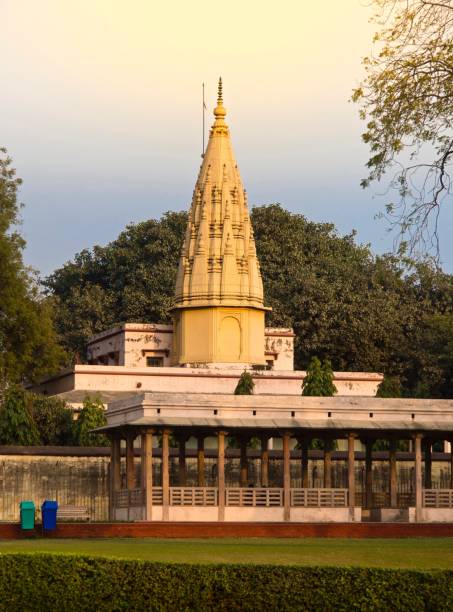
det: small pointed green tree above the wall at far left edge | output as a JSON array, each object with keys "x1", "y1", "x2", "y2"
[{"x1": 0, "y1": 385, "x2": 40, "y2": 446}]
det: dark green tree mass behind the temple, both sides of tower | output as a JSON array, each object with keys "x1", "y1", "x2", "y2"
[{"x1": 46, "y1": 204, "x2": 453, "y2": 397}]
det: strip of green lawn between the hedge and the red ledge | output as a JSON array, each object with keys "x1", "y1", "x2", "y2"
[{"x1": 0, "y1": 538, "x2": 453, "y2": 569}]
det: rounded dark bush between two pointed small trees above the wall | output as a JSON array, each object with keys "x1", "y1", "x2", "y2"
[{"x1": 29, "y1": 395, "x2": 73, "y2": 446}]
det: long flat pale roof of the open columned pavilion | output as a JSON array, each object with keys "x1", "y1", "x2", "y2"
[{"x1": 99, "y1": 393, "x2": 453, "y2": 437}]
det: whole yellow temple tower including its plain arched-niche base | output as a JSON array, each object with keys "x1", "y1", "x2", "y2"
[{"x1": 173, "y1": 79, "x2": 267, "y2": 366}]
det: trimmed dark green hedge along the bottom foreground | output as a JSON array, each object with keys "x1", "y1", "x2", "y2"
[{"x1": 0, "y1": 554, "x2": 453, "y2": 612}]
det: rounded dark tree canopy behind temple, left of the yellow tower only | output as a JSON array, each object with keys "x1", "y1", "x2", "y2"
[{"x1": 45, "y1": 212, "x2": 187, "y2": 359}]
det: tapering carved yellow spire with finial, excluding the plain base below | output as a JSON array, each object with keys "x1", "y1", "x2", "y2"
[{"x1": 175, "y1": 77, "x2": 263, "y2": 307}]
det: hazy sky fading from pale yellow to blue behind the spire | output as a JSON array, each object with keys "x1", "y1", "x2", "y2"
[{"x1": 0, "y1": 0, "x2": 453, "y2": 274}]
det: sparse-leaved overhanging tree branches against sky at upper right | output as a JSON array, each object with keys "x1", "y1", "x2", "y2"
[{"x1": 353, "y1": 0, "x2": 453, "y2": 252}]
